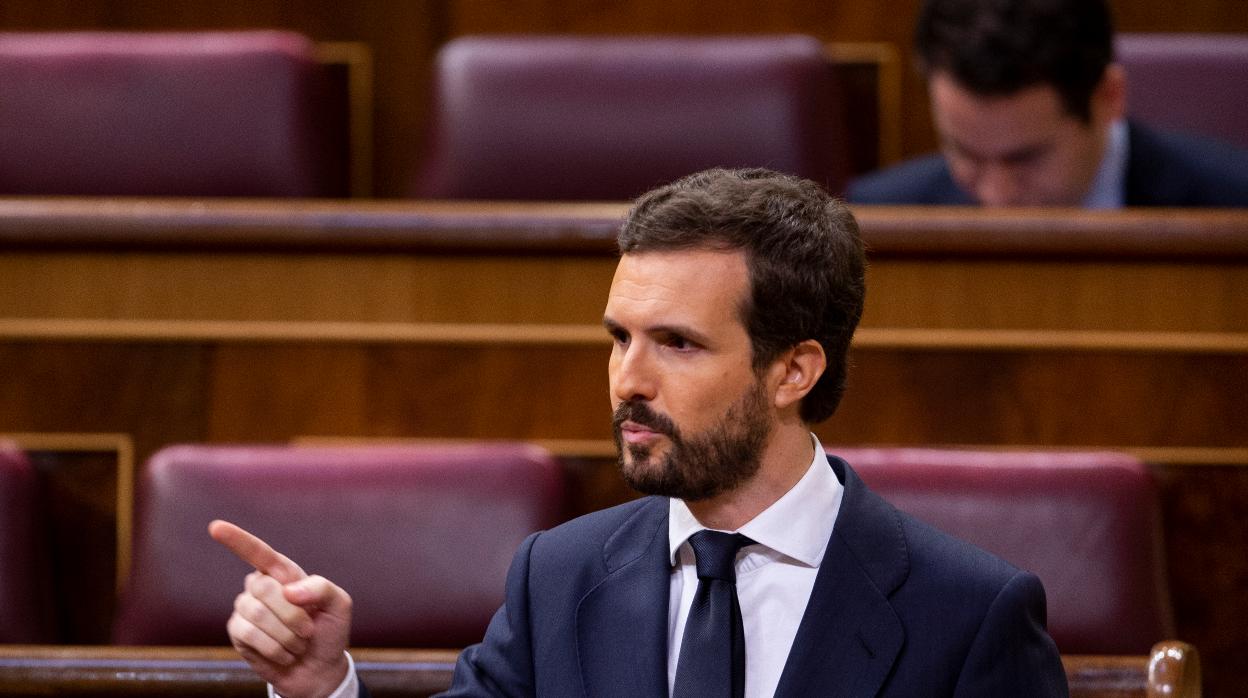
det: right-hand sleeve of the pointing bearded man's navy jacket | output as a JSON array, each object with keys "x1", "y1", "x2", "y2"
[{"x1": 953, "y1": 572, "x2": 1070, "y2": 698}]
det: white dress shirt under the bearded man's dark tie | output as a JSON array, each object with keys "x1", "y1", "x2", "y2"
[{"x1": 668, "y1": 435, "x2": 845, "y2": 698}]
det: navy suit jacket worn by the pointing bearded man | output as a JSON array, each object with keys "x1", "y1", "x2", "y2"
[{"x1": 426, "y1": 457, "x2": 1067, "y2": 698}]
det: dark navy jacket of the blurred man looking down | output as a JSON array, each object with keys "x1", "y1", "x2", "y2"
[{"x1": 845, "y1": 121, "x2": 1248, "y2": 206}]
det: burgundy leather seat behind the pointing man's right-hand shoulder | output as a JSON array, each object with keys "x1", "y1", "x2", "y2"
[{"x1": 829, "y1": 448, "x2": 1173, "y2": 654}]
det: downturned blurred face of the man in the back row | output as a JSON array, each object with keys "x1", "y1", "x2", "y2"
[{"x1": 929, "y1": 71, "x2": 1117, "y2": 206}]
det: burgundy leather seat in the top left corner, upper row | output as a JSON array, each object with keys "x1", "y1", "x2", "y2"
[{"x1": 0, "y1": 31, "x2": 347, "y2": 196}]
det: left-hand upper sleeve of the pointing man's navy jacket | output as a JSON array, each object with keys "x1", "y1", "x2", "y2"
[{"x1": 441, "y1": 533, "x2": 539, "y2": 698}]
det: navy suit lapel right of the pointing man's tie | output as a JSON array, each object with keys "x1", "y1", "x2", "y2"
[{"x1": 776, "y1": 458, "x2": 909, "y2": 697}]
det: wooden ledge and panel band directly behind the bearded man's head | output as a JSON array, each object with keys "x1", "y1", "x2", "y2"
[{"x1": 0, "y1": 200, "x2": 1248, "y2": 332}]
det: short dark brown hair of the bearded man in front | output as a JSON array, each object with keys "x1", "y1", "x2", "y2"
[{"x1": 619, "y1": 169, "x2": 866, "y2": 423}]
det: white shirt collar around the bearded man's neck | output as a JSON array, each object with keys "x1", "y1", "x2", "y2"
[{"x1": 668, "y1": 435, "x2": 845, "y2": 567}]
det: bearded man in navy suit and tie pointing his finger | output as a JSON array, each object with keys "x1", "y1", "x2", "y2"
[{"x1": 211, "y1": 170, "x2": 1067, "y2": 698}]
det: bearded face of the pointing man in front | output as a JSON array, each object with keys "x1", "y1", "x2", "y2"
[{"x1": 604, "y1": 250, "x2": 774, "y2": 501}]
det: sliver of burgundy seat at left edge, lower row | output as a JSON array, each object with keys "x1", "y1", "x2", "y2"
[{"x1": 0, "y1": 442, "x2": 54, "y2": 643}]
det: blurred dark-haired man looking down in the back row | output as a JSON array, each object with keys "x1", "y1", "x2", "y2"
[{"x1": 846, "y1": 0, "x2": 1248, "y2": 209}]
